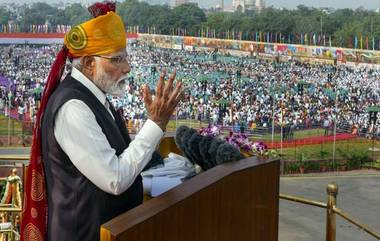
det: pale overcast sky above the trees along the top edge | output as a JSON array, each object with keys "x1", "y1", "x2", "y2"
[{"x1": 0, "y1": 0, "x2": 380, "y2": 9}]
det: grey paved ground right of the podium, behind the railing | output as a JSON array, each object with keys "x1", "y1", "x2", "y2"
[{"x1": 279, "y1": 174, "x2": 380, "y2": 241}]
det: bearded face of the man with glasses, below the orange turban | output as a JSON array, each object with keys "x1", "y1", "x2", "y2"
[{"x1": 93, "y1": 51, "x2": 131, "y2": 96}]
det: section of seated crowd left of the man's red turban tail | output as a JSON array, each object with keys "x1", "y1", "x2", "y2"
[{"x1": 0, "y1": 45, "x2": 59, "y2": 121}]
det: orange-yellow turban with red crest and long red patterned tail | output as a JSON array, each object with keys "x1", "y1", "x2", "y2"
[{"x1": 21, "y1": 2, "x2": 126, "y2": 241}]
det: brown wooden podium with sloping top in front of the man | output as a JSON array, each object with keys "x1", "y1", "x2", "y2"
[{"x1": 101, "y1": 137, "x2": 280, "y2": 241}]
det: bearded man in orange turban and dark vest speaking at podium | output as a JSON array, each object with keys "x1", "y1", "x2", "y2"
[{"x1": 21, "y1": 3, "x2": 182, "y2": 241}]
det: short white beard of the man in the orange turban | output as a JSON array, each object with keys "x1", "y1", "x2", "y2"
[{"x1": 94, "y1": 63, "x2": 127, "y2": 97}]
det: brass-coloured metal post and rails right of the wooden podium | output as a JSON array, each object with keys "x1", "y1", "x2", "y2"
[{"x1": 280, "y1": 183, "x2": 380, "y2": 241}]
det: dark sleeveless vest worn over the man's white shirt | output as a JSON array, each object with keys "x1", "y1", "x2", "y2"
[{"x1": 42, "y1": 76, "x2": 143, "y2": 241}]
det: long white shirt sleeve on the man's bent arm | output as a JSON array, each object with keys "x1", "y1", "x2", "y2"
[{"x1": 54, "y1": 100, "x2": 163, "y2": 195}]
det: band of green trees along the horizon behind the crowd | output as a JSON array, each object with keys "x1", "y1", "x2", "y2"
[{"x1": 0, "y1": 0, "x2": 380, "y2": 47}]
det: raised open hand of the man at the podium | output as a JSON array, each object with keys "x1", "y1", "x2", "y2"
[{"x1": 143, "y1": 68, "x2": 183, "y2": 131}]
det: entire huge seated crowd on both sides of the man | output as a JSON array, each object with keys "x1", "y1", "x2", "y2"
[{"x1": 0, "y1": 44, "x2": 380, "y2": 137}]
